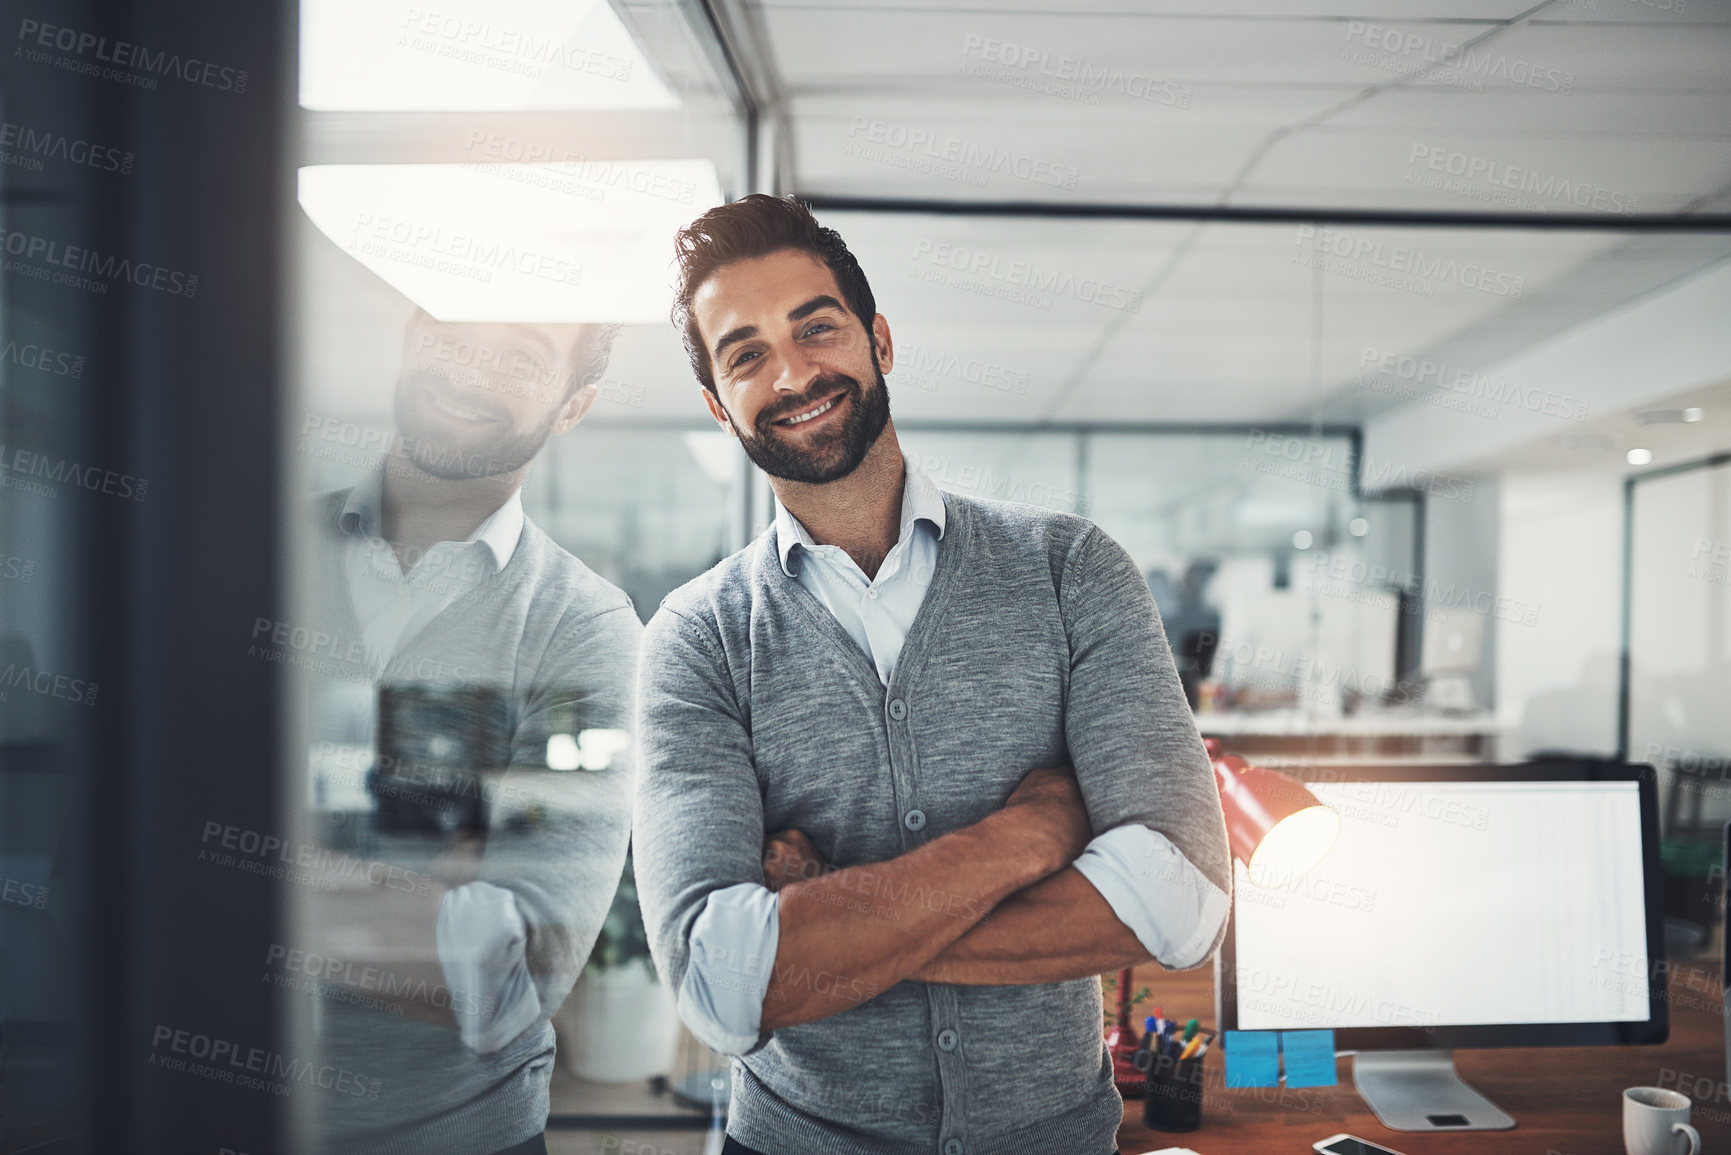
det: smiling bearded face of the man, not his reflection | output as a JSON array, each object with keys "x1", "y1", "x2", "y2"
[{"x1": 691, "y1": 249, "x2": 893, "y2": 485}]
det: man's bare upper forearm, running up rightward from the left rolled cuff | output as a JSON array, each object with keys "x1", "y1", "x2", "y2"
[{"x1": 762, "y1": 810, "x2": 1059, "y2": 1030}]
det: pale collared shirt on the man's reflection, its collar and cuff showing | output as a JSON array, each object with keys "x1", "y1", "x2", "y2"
[{"x1": 328, "y1": 469, "x2": 542, "y2": 1055}]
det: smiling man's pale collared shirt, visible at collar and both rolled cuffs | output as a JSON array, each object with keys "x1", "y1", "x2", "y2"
[{"x1": 679, "y1": 455, "x2": 1229, "y2": 1055}]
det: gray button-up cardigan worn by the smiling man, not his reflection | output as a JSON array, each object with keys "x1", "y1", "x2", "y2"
[{"x1": 634, "y1": 494, "x2": 1232, "y2": 1155}]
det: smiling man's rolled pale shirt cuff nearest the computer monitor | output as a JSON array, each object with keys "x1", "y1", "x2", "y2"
[{"x1": 1075, "y1": 823, "x2": 1231, "y2": 970}]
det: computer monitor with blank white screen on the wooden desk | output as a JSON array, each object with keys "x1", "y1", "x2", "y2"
[{"x1": 1215, "y1": 762, "x2": 1669, "y2": 1131}]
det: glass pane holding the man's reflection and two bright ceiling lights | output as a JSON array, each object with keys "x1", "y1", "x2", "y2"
[{"x1": 285, "y1": 0, "x2": 744, "y2": 1152}]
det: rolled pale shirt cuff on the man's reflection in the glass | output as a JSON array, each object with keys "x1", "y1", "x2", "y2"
[{"x1": 438, "y1": 881, "x2": 542, "y2": 1055}]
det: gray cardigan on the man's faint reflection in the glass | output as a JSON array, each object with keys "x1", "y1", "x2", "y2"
[{"x1": 290, "y1": 490, "x2": 642, "y2": 1155}]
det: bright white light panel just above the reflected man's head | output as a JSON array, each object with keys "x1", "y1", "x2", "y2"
[{"x1": 299, "y1": 159, "x2": 722, "y2": 324}]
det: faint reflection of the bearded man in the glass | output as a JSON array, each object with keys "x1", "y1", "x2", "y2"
[{"x1": 294, "y1": 313, "x2": 640, "y2": 1155}]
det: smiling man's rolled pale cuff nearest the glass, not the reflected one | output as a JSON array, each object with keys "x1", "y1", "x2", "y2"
[{"x1": 679, "y1": 883, "x2": 781, "y2": 1055}]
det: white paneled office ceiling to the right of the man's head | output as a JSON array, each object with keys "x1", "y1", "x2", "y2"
[{"x1": 730, "y1": 0, "x2": 1731, "y2": 421}]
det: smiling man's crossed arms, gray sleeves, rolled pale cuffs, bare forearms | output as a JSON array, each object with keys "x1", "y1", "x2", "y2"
[{"x1": 635, "y1": 530, "x2": 1231, "y2": 1055}]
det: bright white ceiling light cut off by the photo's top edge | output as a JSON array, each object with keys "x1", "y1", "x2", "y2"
[{"x1": 301, "y1": 0, "x2": 679, "y2": 113}]
